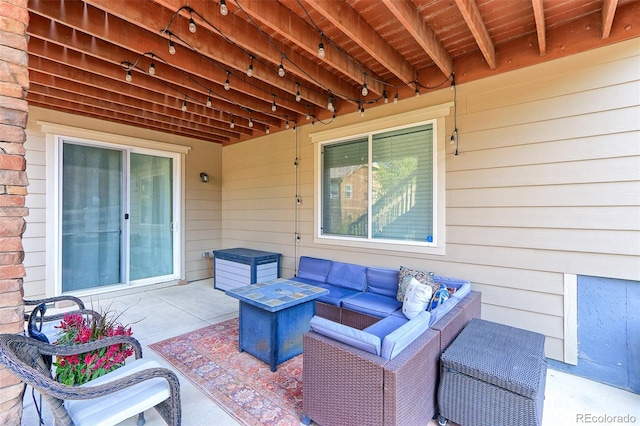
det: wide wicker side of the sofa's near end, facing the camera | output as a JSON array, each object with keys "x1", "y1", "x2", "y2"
[{"x1": 302, "y1": 331, "x2": 387, "y2": 426}]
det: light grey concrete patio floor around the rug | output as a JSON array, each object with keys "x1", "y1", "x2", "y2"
[{"x1": 22, "y1": 279, "x2": 640, "y2": 426}]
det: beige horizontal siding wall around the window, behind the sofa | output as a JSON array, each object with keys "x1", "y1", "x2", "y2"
[{"x1": 222, "y1": 39, "x2": 640, "y2": 360}]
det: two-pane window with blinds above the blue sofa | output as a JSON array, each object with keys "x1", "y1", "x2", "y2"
[{"x1": 319, "y1": 122, "x2": 436, "y2": 245}]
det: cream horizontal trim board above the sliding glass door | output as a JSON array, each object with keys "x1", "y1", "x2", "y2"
[{"x1": 36, "y1": 120, "x2": 191, "y2": 154}]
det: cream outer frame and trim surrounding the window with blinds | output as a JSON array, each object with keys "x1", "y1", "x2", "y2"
[{"x1": 309, "y1": 102, "x2": 453, "y2": 255}]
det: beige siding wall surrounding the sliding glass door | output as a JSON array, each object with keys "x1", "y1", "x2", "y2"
[{"x1": 23, "y1": 107, "x2": 222, "y2": 298}]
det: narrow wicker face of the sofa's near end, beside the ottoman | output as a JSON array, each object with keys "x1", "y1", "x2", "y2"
[{"x1": 384, "y1": 329, "x2": 442, "y2": 425}]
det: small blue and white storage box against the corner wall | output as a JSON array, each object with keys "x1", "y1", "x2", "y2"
[{"x1": 213, "y1": 248, "x2": 280, "y2": 290}]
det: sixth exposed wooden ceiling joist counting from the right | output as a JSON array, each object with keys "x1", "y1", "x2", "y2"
[{"x1": 237, "y1": 0, "x2": 384, "y2": 95}]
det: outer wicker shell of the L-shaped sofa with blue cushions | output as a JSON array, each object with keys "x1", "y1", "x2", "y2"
[{"x1": 302, "y1": 292, "x2": 480, "y2": 426}]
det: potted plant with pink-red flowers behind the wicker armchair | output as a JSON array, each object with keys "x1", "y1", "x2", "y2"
[{"x1": 53, "y1": 312, "x2": 133, "y2": 386}]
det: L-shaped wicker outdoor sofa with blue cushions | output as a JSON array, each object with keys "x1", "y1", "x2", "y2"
[{"x1": 291, "y1": 256, "x2": 480, "y2": 426}]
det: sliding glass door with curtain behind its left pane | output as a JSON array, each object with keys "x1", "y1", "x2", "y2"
[{"x1": 60, "y1": 141, "x2": 178, "y2": 293}]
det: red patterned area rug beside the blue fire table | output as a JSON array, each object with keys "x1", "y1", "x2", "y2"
[{"x1": 149, "y1": 318, "x2": 302, "y2": 426}]
